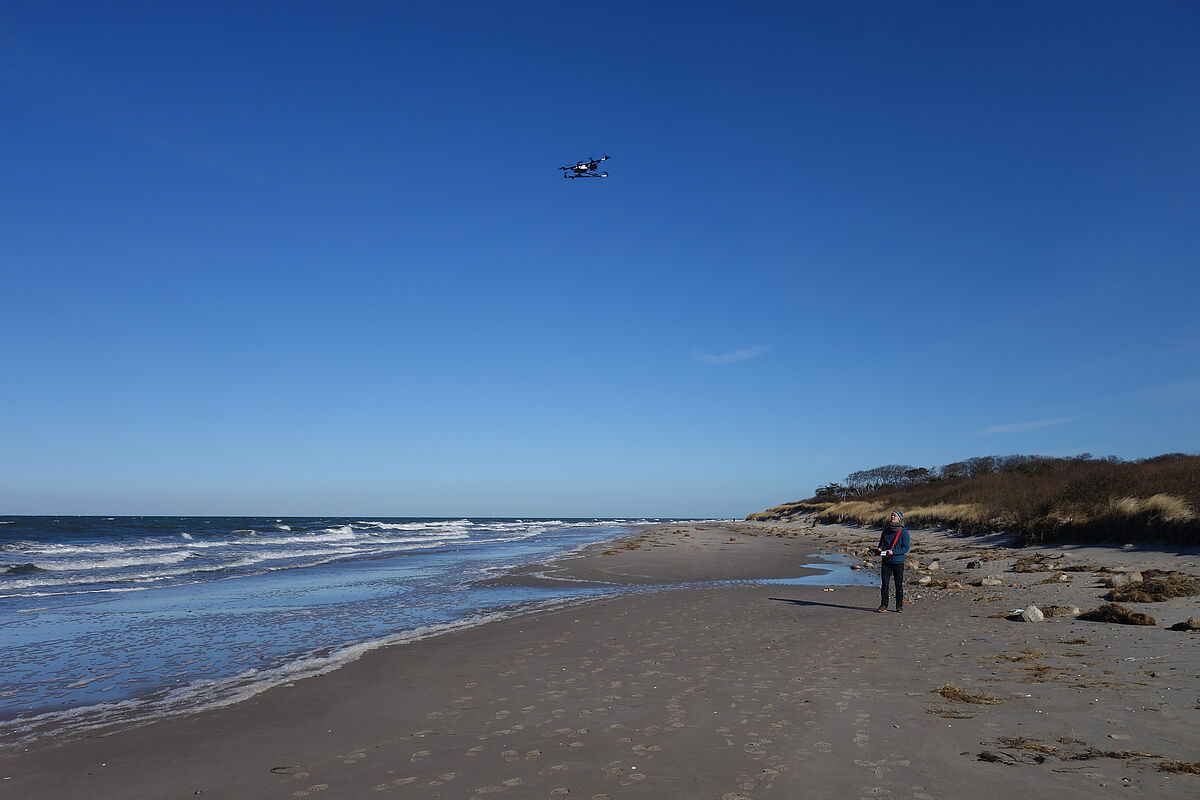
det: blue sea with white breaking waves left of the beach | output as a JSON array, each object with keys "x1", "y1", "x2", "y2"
[{"x1": 0, "y1": 517, "x2": 696, "y2": 744}]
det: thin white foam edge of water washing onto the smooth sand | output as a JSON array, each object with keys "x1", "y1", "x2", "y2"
[{"x1": 0, "y1": 599, "x2": 592, "y2": 744}]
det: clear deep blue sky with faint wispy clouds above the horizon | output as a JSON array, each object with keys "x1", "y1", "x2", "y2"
[{"x1": 0, "y1": 1, "x2": 1200, "y2": 517}]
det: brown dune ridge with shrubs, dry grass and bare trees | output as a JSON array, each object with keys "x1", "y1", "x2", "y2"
[{"x1": 750, "y1": 453, "x2": 1200, "y2": 545}]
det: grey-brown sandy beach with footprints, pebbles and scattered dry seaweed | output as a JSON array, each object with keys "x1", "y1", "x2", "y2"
[{"x1": 0, "y1": 523, "x2": 1200, "y2": 800}]
